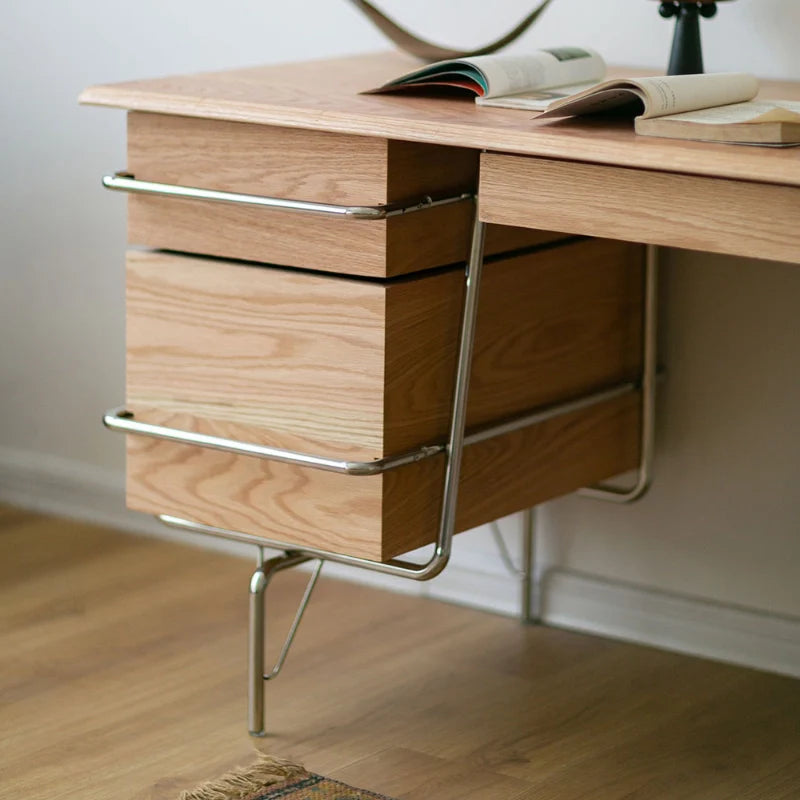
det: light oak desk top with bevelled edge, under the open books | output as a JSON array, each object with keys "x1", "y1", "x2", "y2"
[{"x1": 80, "y1": 52, "x2": 800, "y2": 188}]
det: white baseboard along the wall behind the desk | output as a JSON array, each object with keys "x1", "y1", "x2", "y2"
[{"x1": 0, "y1": 448, "x2": 800, "y2": 678}]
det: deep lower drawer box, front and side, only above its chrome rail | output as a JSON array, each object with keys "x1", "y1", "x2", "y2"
[{"x1": 126, "y1": 240, "x2": 642, "y2": 460}]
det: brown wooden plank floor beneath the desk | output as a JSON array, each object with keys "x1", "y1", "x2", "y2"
[{"x1": 0, "y1": 508, "x2": 800, "y2": 800}]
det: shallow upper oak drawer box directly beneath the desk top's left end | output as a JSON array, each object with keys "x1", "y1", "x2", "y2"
[{"x1": 122, "y1": 112, "x2": 564, "y2": 277}]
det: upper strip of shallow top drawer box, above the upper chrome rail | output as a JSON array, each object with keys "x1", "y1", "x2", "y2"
[{"x1": 128, "y1": 112, "x2": 478, "y2": 206}]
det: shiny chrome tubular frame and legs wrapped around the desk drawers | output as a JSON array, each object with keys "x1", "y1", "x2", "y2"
[{"x1": 103, "y1": 167, "x2": 657, "y2": 736}]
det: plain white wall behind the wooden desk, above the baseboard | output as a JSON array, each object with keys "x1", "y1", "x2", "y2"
[{"x1": 0, "y1": 0, "x2": 800, "y2": 660}]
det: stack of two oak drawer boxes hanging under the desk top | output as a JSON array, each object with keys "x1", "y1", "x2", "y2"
[{"x1": 119, "y1": 112, "x2": 643, "y2": 560}]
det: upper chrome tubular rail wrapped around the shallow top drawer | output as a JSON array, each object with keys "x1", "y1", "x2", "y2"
[{"x1": 103, "y1": 172, "x2": 473, "y2": 220}]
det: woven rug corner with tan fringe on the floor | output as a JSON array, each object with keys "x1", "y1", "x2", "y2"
[{"x1": 179, "y1": 755, "x2": 391, "y2": 800}]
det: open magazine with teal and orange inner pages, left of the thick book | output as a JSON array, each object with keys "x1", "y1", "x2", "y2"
[{"x1": 365, "y1": 47, "x2": 606, "y2": 111}]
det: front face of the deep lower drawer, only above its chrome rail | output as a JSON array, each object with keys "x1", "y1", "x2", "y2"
[{"x1": 126, "y1": 251, "x2": 386, "y2": 459}]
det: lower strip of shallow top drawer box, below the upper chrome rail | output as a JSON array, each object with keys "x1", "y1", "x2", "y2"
[{"x1": 128, "y1": 195, "x2": 564, "y2": 278}]
